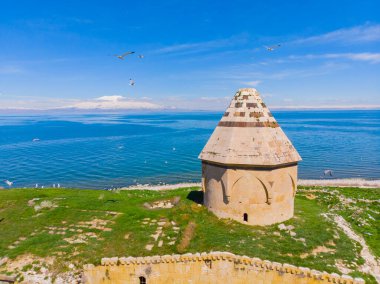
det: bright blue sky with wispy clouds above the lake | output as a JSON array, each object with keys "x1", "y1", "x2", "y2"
[{"x1": 0, "y1": 0, "x2": 380, "y2": 110}]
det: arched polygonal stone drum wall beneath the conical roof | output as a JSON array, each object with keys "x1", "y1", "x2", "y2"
[{"x1": 202, "y1": 162, "x2": 297, "y2": 225}]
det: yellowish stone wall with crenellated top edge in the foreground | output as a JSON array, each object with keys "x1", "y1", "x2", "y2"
[{"x1": 84, "y1": 252, "x2": 364, "y2": 284}]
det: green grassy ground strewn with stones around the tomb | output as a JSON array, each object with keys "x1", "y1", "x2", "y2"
[{"x1": 0, "y1": 187, "x2": 380, "y2": 282}]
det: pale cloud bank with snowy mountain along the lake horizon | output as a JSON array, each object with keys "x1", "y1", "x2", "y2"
[{"x1": 0, "y1": 93, "x2": 380, "y2": 112}]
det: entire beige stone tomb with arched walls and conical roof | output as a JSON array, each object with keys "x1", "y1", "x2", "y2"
[{"x1": 199, "y1": 89, "x2": 301, "y2": 225}]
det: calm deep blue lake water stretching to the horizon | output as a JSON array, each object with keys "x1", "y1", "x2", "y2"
[{"x1": 0, "y1": 111, "x2": 380, "y2": 188}]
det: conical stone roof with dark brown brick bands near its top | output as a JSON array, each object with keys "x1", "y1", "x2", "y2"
[{"x1": 199, "y1": 89, "x2": 301, "y2": 167}]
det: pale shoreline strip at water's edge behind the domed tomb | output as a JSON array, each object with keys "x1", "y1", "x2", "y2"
[{"x1": 119, "y1": 178, "x2": 380, "y2": 190}]
